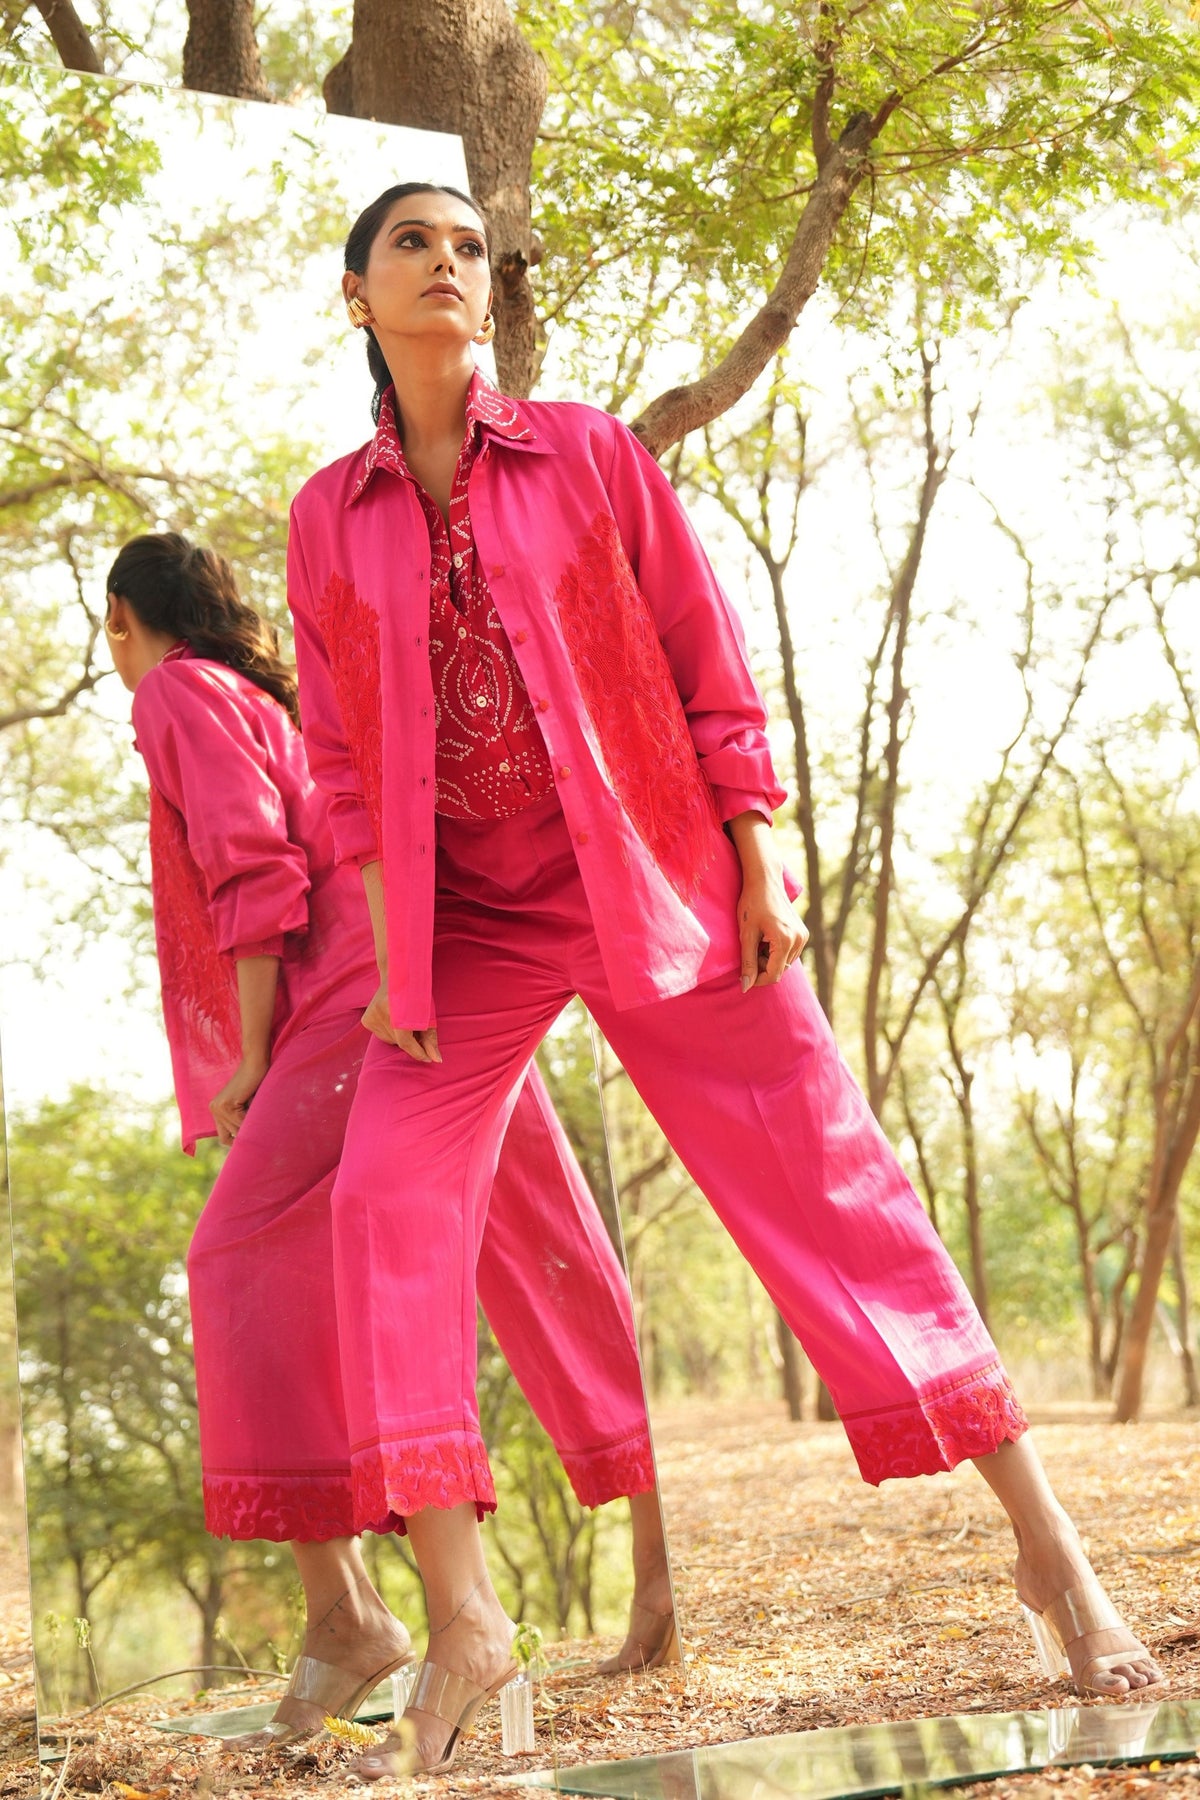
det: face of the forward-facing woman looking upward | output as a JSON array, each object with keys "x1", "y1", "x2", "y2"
[{"x1": 342, "y1": 193, "x2": 491, "y2": 344}]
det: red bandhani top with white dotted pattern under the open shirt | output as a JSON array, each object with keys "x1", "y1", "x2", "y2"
[{"x1": 374, "y1": 390, "x2": 554, "y2": 819}]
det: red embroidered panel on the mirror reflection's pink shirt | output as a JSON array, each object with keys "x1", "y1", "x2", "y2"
[{"x1": 149, "y1": 785, "x2": 241, "y2": 1062}]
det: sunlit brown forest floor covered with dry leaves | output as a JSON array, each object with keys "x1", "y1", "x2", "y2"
[{"x1": 21, "y1": 1404, "x2": 1200, "y2": 1800}]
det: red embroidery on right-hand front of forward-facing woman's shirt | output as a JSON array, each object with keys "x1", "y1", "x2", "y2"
[{"x1": 554, "y1": 513, "x2": 718, "y2": 898}]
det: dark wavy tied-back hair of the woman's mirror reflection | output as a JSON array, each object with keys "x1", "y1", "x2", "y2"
[{"x1": 108, "y1": 531, "x2": 300, "y2": 725}]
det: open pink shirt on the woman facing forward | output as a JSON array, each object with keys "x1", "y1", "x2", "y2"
[{"x1": 288, "y1": 379, "x2": 786, "y2": 1030}]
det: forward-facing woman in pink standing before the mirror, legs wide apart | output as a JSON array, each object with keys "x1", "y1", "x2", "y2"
[{"x1": 290, "y1": 184, "x2": 1159, "y2": 1778}]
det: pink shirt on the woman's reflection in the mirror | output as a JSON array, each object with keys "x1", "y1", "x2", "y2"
[{"x1": 133, "y1": 652, "x2": 378, "y2": 1154}]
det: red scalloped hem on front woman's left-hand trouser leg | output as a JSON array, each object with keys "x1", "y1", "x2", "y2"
[{"x1": 351, "y1": 1431, "x2": 497, "y2": 1535}]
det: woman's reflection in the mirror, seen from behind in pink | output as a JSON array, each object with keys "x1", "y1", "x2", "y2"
[{"x1": 106, "y1": 533, "x2": 669, "y2": 1742}]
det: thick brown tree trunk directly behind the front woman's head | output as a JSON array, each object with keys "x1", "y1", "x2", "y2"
[{"x1": 324, "y1": 0, "x2": 549, "y2": 394}]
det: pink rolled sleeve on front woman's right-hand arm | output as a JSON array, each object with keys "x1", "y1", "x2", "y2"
[{"x1": 606, "y1": 419, "x2": 786, "y2": 821}]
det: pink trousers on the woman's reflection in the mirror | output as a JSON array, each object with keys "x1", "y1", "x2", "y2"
[{"x1": 187, "y1": 1008, "x2": 655, "y2": 1543}]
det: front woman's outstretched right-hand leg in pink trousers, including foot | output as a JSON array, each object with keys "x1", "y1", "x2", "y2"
[{"x1": 583, "y1": 968, "x2": 1157, "y2": 1692}]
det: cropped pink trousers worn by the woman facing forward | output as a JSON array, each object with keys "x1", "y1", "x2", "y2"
[{"x1": 333, "y1": 799, "x2": 1025, "y2": 1521}]
